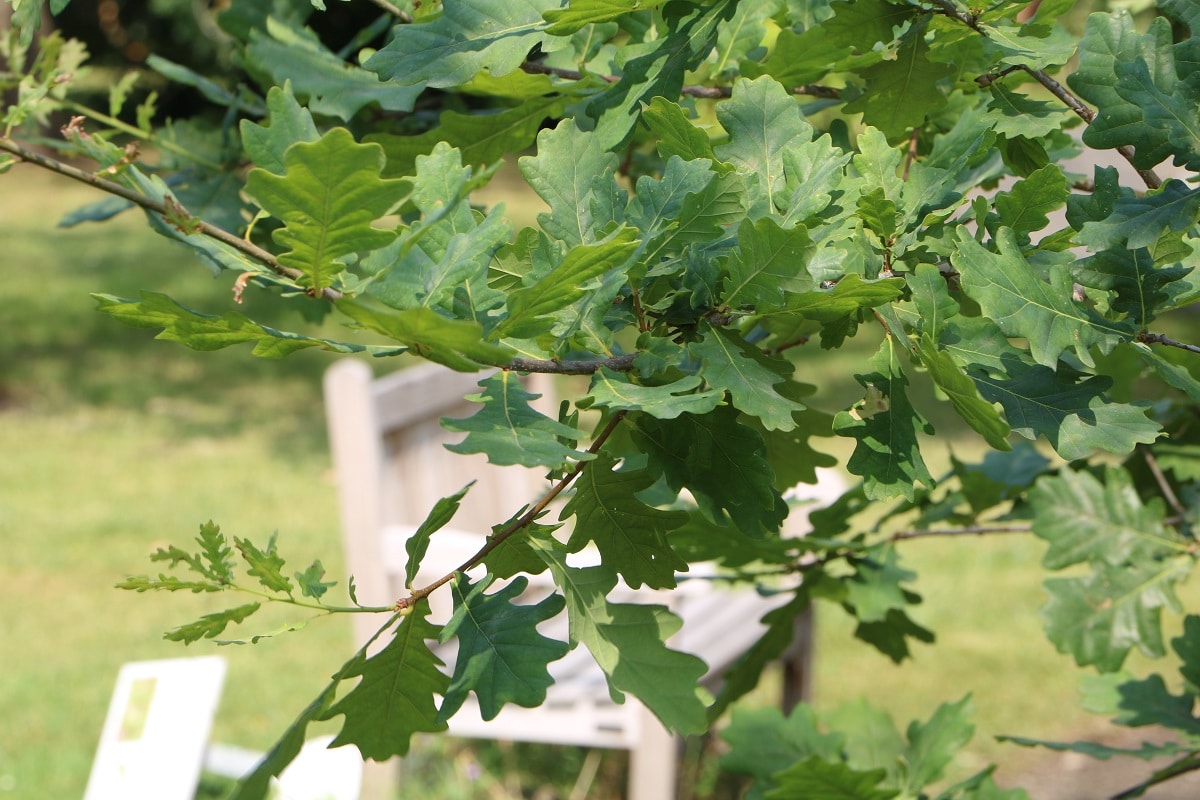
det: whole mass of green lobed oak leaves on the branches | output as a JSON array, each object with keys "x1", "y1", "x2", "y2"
[{"x1": 7, "y1": 0, "x2": 1200, "y2": 798}]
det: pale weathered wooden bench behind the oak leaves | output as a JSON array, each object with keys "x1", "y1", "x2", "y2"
[{"x1": 325, "y1": 359, "x2": 841, "y2": 800}]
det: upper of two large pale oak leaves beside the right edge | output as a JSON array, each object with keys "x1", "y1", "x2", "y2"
[{"x1": 1030, "y1": 465, "x2": 1187, "y2": 570}]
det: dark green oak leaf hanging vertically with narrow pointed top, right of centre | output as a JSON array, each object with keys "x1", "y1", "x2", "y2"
[{"x1": 834, "y1": 337, "x2": 934, "y2": 500}]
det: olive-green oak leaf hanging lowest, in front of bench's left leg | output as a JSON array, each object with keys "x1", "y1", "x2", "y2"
[{"x1": 319, "y1": 603, "x2": 450, "y2": 762}]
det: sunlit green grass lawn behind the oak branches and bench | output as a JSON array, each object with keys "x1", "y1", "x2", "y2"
[{"x1": 0, "y1": 167, "x2": 1161, "y2": 800}]
